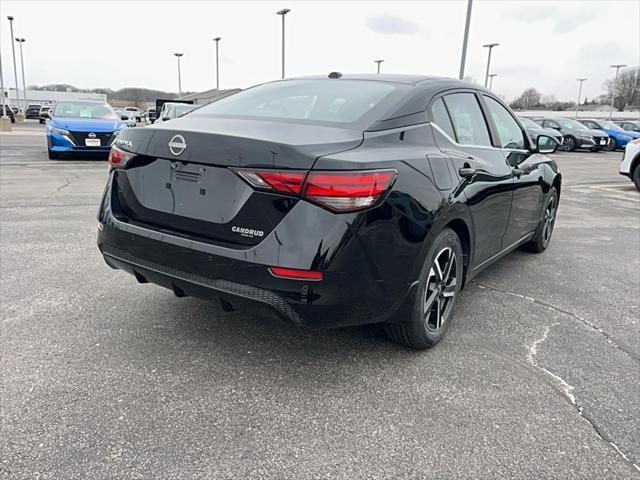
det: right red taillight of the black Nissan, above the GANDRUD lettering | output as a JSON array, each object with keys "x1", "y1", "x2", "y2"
[{"x1": 235, "y1": 169, "x2": 396, "y2": 212}]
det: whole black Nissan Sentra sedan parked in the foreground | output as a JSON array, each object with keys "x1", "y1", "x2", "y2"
[{"x1": 98, "y1": 72, "x2": 561, "y2": 348}]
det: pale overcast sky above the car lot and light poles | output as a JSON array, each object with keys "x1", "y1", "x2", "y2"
[{"x1": 0, "y1": 0, "x2": 640, "y2": 100}]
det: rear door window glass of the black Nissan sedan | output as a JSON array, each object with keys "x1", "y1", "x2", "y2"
[{"x1": 444, "y1": 93, "x2": 491, "y2": 146}]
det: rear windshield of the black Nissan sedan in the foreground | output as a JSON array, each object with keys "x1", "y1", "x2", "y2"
[{"x1": 198, "y1": 80, "x2": 396, "y2": 123}]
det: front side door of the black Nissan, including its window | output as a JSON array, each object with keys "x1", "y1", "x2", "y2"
[{"x1": 482, "y1": 94, "x2": 546, "y2": 248}]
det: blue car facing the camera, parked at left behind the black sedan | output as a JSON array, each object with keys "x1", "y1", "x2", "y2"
[{"x1": 46, "y1": 100, "x2": 125, "y2": 159}]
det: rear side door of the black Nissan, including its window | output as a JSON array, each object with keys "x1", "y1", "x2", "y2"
[{"x1": 429, "y1": 90, "x2": 513, "y2": 266}]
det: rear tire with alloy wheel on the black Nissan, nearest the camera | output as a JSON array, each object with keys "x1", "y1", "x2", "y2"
[{"x1": 384, "y1": 228, "x2": 463, "y2": 350}]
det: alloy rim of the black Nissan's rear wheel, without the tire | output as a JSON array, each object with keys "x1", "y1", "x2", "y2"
[{"x1": 423, "y1": 247, "x2": 457, "y2": 332}]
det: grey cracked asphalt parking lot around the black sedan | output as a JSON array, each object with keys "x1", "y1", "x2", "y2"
[{"x1": 0, "y1": 124, "x2": 640, "y2": 479}]
